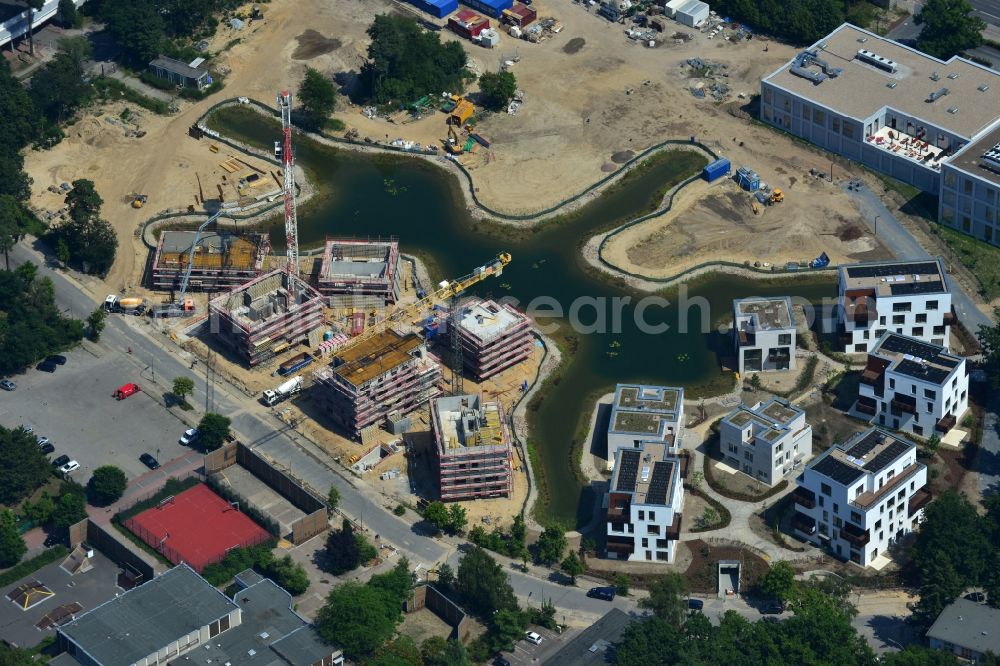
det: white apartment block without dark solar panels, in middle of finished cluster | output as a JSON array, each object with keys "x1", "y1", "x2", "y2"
[{"x1": 719, "y1": 398, "x2": 812, "y2": 486}]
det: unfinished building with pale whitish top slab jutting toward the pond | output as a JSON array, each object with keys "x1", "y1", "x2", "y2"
[{"x1": 459, "y1": 298, "x2": 535, "y2": 381}]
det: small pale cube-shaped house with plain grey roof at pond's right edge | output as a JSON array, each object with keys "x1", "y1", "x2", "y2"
[{"x1": 733, "y1": 296, "x2": 795, "y2": 373}]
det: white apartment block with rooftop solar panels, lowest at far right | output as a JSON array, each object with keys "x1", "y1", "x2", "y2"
[{"x1": 792, "y1": 428, "x2": 931, "y2": 567}]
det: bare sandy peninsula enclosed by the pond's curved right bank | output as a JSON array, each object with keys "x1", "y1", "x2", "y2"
[{"x1": 603, "y1": 170, "x2": 891, "y2": 278}]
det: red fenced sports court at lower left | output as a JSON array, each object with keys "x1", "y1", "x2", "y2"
[{"x1": 125, "y1": 484, "x2": 271, "y2": 572}]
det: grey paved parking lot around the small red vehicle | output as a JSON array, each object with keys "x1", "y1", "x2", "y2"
[{"x1": 0, "y1": 345, "x2": 190, "y2": 483}]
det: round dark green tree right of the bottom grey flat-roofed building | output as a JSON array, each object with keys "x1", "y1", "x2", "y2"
[{"x1": 316, "y1": 582, "x2": 400, "y2": 661}]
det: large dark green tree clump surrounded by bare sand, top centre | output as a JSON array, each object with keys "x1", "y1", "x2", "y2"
[{"x1": 361, "y1": 14, "x2": 466, "y2": 104}]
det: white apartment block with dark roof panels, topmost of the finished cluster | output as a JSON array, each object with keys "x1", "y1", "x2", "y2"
[{"x1": 837, "y1": 259, "x2": 956, "y2": 352}]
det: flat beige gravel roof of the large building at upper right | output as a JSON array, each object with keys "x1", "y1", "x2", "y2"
[{"x1": 764, "y1": 23, "x2": 1000, "y2": 140}]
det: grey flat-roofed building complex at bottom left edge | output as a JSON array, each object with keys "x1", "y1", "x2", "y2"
[{"x1": 57, "y1": 564, "x2": 344, "y2": 666}]
